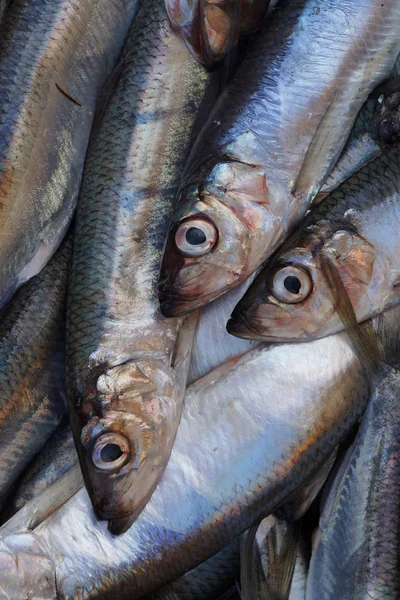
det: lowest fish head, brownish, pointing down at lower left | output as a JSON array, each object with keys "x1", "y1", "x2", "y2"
[{"x1": 75, "y1": 361, "x2": 176, "y2": 535}]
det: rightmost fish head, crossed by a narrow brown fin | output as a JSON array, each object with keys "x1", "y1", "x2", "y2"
[{"x1": 227, "y1": 224, "x2": 384, "y2": 342}]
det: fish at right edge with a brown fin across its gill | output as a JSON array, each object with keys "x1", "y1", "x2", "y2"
[{"x1": 227, "y1": 135, "x2": 400, "y2": 342}]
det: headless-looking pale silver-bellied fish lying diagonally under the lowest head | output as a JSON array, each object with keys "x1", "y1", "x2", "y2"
[{"x1": 0, "y1": 335, "x2": 369, "y2": 600}]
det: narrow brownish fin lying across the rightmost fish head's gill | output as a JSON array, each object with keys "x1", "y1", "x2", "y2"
[{"x1": 319, "y1": 250, "x2": 383, "y2": 378}]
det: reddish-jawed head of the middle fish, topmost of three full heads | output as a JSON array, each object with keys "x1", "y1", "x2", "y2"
[{"x1": 159, "y1": 161, "x2": 286, "y2": 317}]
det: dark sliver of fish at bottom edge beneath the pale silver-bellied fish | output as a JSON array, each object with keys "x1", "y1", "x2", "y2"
[{"x1": 145, "y1": 539, "x2": 240, "y2": 600}]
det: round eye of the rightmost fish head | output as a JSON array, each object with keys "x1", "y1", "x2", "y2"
[{"x1": 272, "y1": 265, "x2": 312, "y2": 304}]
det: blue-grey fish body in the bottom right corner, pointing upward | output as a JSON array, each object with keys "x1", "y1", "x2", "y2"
[{"x1": 307, "y1": 298, "x2": 400, "y2": 600}]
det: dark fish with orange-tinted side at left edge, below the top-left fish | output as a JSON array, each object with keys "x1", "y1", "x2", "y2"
[{"x1": 0, "y1": 238, "x2": 71, "y2": 503}]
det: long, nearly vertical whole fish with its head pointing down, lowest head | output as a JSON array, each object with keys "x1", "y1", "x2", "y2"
[{"x1": 67, "y1": 0, "x2": 219, "y2": 535}]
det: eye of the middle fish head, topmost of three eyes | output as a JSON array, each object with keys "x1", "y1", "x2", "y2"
[{"x1": 175, "y1": 218, "x2": 218, "y2": 256}]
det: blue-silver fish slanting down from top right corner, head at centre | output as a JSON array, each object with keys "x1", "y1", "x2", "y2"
[{"x1": 159, "y1": 0, "x2": 400, "y2": 317}]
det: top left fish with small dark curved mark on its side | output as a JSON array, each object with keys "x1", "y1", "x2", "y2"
[{"x1": 0, "y1": 0, "x2": 136, "y2": 307}]
